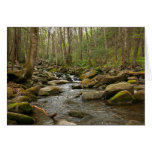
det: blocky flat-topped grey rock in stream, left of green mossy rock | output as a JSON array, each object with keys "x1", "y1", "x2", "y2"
[{"x1": 82, "y1": 91, "x2": 103, "y2": 100}]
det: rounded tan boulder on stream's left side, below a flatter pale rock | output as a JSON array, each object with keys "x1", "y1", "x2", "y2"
[{"x1": 39, "y1": 86, "x2": 61, "y2": 96}]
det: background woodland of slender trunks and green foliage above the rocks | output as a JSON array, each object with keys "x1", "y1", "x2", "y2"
[{"x1": 7, "y1": 27, "x2": 144, "y2": 68}]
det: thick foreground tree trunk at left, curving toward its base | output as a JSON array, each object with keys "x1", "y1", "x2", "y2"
[{"x1": 22, "y1": 27, "x2": 39, "y2": 79}]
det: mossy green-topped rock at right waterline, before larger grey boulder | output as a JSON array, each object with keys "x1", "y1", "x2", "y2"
[{"x1": 107, "y1": 90, "x2": 135, "y2": 105}]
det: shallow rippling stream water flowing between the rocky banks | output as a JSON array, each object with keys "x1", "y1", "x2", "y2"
[{"x1": 33, "y1": 76, "x2": 144, "y2": 125}]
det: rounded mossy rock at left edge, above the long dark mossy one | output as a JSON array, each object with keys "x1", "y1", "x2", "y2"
[{"x1": 8, "y1": 102, "x2": 33, "y2": 114}]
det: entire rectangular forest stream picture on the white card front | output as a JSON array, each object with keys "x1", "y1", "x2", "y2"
[{"x1": 7, "y1": 27, "x2": 145, "y2": 125}]
